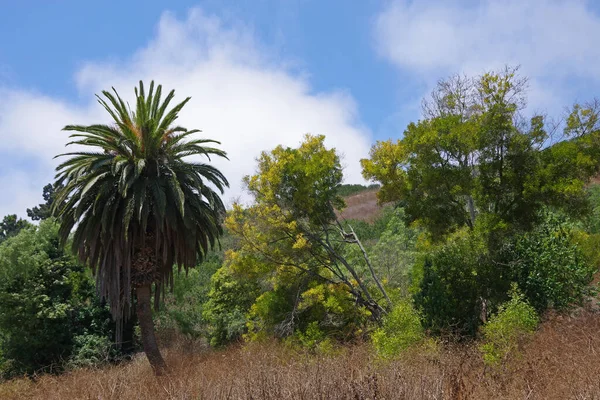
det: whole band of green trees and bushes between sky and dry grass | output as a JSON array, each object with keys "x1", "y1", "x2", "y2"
[{"x1": 0, "y1": 69, "x2": 600, "y2": 394}]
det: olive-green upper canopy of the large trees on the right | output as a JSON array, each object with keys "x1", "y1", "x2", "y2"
[{"x1": 361, "y1": 68, "x2": 600, "y2": 240}]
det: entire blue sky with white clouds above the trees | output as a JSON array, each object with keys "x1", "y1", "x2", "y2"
[{"x1": 0, "y1": 0, "x2": 600, "y2": 217}]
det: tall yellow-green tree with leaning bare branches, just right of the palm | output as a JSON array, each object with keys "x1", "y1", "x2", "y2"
[{"x1": 225, "y1": 135, "x2": 391, "y2": 335}]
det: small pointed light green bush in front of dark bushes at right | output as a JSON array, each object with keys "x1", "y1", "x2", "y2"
[{"x1": 480, "y1": 285, "x2": 538, "y2": 366}]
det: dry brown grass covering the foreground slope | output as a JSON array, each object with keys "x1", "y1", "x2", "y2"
[{"x1": 0, "y1": 311, "x2": 600, "y2": 400}]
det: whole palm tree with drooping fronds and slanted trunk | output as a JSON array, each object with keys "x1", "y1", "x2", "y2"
[{"x1": 54, "y1": 81, "x2": 229, "y2": 375}]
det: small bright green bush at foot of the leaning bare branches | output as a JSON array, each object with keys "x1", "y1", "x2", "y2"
[{"x1": 371, "y1": 300, "x2": 425, "y2": 358}]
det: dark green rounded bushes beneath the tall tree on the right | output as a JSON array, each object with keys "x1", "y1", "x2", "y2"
[{"x1": 413, "y1": 212, "x2": 598, "y2": 335}]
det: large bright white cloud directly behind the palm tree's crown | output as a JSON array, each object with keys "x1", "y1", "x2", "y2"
[{"x1": 0, "y1": 9, "x2": 370, "y2": 215}]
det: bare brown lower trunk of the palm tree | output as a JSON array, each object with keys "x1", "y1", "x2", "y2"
[{"x1": 136, "y1": 284, "x2": 167, "y2": 376}]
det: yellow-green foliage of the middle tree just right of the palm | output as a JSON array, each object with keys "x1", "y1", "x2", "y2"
[{"x1": 221, "y1": 136, "x2": 390, "y2": 346}]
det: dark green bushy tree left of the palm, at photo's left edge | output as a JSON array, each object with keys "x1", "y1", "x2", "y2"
[{"x1": 0, "y1": 220, "x2": 114, "y2": 376}]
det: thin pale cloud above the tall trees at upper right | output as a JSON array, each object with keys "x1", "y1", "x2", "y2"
[{"x1": 375, "y1": 0, "x2": 600, "y2": 112}]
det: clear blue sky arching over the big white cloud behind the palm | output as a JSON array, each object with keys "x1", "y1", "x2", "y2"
[{"x1": 0, "y1": 0, "x2": 410, "y2": 136}]
